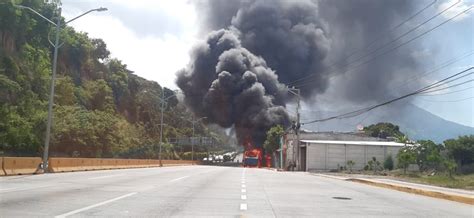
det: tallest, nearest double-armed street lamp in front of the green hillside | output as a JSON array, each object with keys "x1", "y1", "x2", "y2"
[{"x1": 14, "y1": 2, "x2": 107, "y2": 172}]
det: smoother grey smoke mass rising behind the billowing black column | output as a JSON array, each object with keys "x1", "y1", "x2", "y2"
[{"x1": 194, "y1": 0, "x2": 330, "y2": 97}]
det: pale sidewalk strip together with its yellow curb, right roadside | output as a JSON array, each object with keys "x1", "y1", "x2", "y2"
[{"x1": 311, "y1": 173, "x2": 474, "y2": 205}]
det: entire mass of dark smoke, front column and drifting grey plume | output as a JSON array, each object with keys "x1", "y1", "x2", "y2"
[{"x1": 177, "y1": 0, "x2": 417, "y2": 144}]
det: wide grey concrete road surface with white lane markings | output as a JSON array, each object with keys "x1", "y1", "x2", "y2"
[{"x1": 0, "y1": 166, "x2": 474, "y2": 217}]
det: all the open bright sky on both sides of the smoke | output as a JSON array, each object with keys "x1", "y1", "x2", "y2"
[{"x1": 62, "y1": 0, "x2": 474, "y2": 127}]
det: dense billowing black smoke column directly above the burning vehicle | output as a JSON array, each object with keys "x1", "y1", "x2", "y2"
[{"x1": 177, "y1": 30, "x2": 289, "y2": 145}]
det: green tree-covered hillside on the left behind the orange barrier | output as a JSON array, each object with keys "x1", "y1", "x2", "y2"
[{"x1": 0, "y1": 0, "x2": 230, "y2": 158}]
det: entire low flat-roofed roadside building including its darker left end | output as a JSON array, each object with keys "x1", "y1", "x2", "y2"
[{"x1": 275, "y1": 131, "x2": 405, "y2": 171}]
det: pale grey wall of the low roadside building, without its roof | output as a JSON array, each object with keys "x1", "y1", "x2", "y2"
[{"x1": 306, "y1": 144, "x2": 401, "y2": 171}]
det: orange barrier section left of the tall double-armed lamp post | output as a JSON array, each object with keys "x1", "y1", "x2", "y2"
[{"x1": 2, "y1": 157, "x2": 41, "y2": 175}]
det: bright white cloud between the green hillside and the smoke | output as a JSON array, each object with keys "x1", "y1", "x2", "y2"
[{"x1": 63, "y1": 0, "x2": 197, "y2": 89}]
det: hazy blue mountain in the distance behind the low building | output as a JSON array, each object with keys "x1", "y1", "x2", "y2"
[{"x1": 302, "y1": 104, "x2": 474, "y2": 143}]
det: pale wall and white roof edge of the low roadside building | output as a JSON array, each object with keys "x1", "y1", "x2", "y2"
[{"x1": 300, "y1": 140, "x2": 405, "y2": 171}]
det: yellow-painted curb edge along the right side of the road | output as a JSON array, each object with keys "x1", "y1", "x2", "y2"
[{"x1": 346, "y1": 178, "x2": 474, "y2": 205}]
